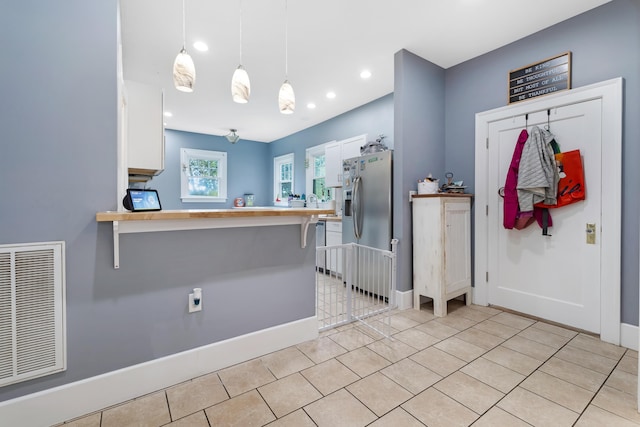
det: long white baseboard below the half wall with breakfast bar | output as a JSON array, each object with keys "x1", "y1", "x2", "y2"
[{"x1": 0, "y1": 316, "x2": 318, "y2": 427}]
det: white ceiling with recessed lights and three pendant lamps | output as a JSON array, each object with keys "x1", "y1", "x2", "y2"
[{"x1": 120, "y1": 0, "x2": 610, "y2": 142}]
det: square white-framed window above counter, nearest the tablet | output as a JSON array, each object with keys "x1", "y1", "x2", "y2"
[{"x1": 180, "y1": 148, "x2": 227, "y2": 203}]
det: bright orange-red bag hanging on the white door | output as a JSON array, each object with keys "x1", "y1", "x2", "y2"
[{"x1": 534, "y1": 150, "x2": 586, "y2": 209}]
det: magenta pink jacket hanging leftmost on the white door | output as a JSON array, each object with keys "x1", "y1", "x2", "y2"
[{"x1": 502, "y1": 129, "x2": 553, "y2": 230}]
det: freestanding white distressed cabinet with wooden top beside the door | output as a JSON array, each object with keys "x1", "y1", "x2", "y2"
[{"x1": 413, "y1": 194, "x2": 471, "y2": 316}]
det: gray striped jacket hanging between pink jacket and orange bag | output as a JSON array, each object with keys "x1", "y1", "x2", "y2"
[{"x1": 517, "y1": 126, "x2": 560, "y2": 212}]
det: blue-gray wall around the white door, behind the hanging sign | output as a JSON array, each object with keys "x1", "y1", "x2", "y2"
[{"x1": 445, "y1": 0, "x2": 640, "y2": 325}]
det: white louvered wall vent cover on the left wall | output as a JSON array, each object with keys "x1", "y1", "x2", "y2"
[{"x1": 0, "y1": 242, "x2": 66, "y2": 387}]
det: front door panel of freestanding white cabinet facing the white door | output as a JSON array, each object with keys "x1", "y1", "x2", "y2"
[{"x1": 443, "y1": 200, "x2": 471, "y2": 293}]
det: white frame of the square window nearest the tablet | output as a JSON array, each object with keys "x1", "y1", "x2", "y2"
[{"x1": 180, "y1": 148, "x2": 227, "y2": 203}]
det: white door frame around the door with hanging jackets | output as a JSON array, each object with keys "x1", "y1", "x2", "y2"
[{"x1": 473, "y1": 77, "x2": 623, "y2": 345}]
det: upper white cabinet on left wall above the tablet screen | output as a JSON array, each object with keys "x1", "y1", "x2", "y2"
[{"x1": 125, "y1": 80, "x2": 164, "y2": 177}]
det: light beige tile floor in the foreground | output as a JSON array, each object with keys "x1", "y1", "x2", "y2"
[{"x1": 57, "y1": 301, "x2": 640, "y2": 427}]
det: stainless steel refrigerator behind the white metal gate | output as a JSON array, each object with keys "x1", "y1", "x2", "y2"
[{"x1": 342, "y1": 151, "x2": 393, "y2": 298}]
